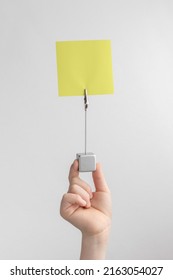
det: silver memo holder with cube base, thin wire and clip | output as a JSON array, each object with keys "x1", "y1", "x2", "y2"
[{"x1": 76, "y1": 89, "x2": 96, "y2": 172}]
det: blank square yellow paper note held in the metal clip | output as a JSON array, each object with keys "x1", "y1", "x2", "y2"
[{"x1": 56, "y1": 40, "x2": 114, "y2": 96}]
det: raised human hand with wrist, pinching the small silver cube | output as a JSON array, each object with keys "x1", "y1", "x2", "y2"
[{"x1": 60, "y1": 160, "x2": 111, "y2": 259}]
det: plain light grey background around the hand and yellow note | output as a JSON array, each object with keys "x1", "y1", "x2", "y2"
[{"x1": 0, "y1": 0, "x2": 173, "y2": 259}]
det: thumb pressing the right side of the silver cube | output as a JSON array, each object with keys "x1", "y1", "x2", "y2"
[{"x1": 92, "y1": 163, "x2": 109, "y2": 192}]
